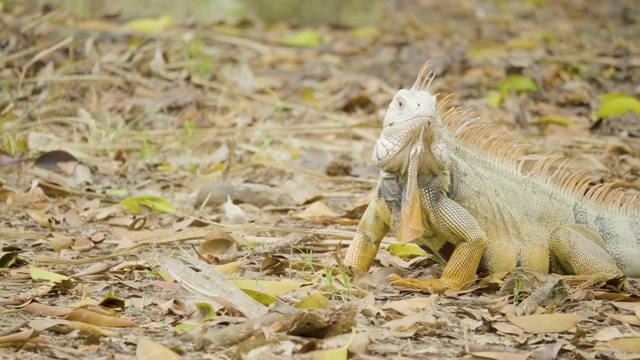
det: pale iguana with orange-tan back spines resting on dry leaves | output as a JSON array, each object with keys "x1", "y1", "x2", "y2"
[{"x1": 344, "y1": 63, "x2": 640, "y2": 292}]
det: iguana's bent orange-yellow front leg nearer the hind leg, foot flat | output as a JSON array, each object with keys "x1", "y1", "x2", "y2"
[{"x1": 389, "y1": 182, "x2": 487, "y2": 293}]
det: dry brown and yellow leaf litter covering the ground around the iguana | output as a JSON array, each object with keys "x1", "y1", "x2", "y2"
[{"x1": 0, "y1": 0, "x2": 640, "y2": 359}]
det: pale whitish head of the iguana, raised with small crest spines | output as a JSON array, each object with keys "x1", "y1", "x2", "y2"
[{"x1": 372, "y1": 64, "x2": 442, "y2": 173}]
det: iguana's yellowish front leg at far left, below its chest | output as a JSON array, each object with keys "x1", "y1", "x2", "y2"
[{"x1": 344, "y1": 195, "x2": 391, "y2": 272}]
